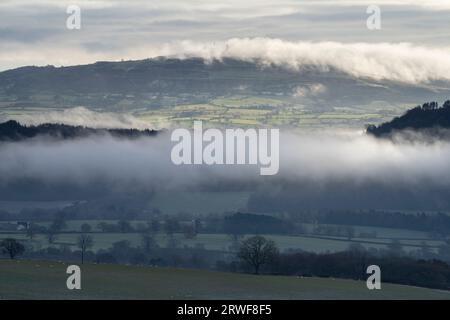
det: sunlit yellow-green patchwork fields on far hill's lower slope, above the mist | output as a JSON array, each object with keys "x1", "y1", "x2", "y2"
[{"x1": 135, "y1": 97, "x2": 398, "y2": 128}]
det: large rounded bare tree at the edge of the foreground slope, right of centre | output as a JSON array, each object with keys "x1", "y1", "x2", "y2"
[{"x1": 238, "y1": 236, "x2": 278, "y2": 274}]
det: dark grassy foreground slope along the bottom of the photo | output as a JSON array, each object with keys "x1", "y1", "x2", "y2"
[{"x1": 0, "y1": 260, "x2": 450, "y2": 299}]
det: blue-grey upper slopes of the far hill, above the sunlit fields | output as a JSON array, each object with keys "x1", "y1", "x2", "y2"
[{"x1": 0, "y1": 58, "x2": 450, "y2": 111}]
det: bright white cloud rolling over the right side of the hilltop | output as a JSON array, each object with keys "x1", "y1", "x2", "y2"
[{"x1": 156, "y1": 38, "x2": 450, "y2": 84}]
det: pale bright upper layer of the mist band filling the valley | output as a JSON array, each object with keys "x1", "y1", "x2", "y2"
[{"x1": 0, "y1": 131, "x2": 450, "y2": 189}]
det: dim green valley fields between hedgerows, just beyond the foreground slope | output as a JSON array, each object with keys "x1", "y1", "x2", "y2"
[{"x1": 0, "y1": 220, "x2": 444, "y2": 253}]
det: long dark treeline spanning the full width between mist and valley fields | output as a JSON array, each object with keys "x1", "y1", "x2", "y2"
[{"x1": 0, "y1": 205, "x2": 450, "y2": 238}]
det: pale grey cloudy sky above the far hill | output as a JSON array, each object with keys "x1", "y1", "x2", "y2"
[{"x1": 0, "y1": 0, "x2": 450, "y2": 72}]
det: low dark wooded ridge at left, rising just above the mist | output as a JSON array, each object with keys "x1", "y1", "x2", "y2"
[{"x1": 0, "y1": 120, "x2": 157, "y2": 141}]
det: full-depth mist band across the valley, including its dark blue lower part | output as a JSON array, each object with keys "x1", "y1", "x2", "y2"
[{"x1": 0, "y1": 130, "x2": 450, "y2": 209}]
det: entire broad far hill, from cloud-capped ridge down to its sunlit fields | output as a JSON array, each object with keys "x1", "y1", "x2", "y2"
[{"x1": 0, "y1": 57, "x2": 450, "y2": 126}]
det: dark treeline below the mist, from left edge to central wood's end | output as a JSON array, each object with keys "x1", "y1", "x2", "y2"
[{"x1": 0, "y1": 210, "x2": 295, "y2": 235}]
